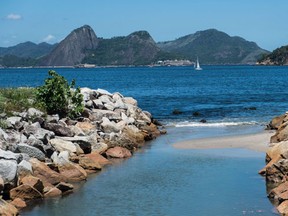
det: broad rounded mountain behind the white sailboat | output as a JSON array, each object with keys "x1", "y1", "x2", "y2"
[{"x1": 157, "y1": 29, "x2": 268, "y2": 64}]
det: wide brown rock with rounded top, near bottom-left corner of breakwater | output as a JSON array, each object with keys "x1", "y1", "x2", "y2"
[{"x1": 10, "y1": 184, "x2": 43, "y2": 201}]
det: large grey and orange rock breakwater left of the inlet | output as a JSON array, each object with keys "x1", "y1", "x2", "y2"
[{"x1": 0, "y1": 88, "x2": 165, "y2": 215}]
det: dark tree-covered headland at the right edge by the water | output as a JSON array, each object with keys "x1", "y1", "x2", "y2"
[{"x1": 257, "y1": 45, "x2": 288, "y2": 65}]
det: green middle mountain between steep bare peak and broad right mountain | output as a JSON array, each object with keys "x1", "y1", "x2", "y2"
[{"x1": 82, "y1": 31, "x2": 169, "y2": 65}]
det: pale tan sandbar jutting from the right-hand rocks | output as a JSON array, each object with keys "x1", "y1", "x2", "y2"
[{"x1": 173, "y1": 131, "x2": 274, "y2": 152}]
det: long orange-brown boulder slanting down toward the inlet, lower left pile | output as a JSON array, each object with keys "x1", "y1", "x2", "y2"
[{"x1": 29, "y1": 158, "x2": 66, "y2": 186}]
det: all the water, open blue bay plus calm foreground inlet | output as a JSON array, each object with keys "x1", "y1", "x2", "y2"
[{"x1": 0, "y1": 66, "x2": 288, "y2": 216}]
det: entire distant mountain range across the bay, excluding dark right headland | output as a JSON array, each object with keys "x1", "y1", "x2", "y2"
[{"x1": 0, "y1": 25, "x2": 269, "y2": 67}]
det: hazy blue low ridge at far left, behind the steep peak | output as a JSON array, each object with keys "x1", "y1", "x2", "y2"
[{"x1": 0, "y1": 41, "x2": 57, "y2": 58}]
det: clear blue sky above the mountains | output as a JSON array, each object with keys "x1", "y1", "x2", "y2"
[{"x1": 0, "y1": 0, "x2": 288, "y2": 50}]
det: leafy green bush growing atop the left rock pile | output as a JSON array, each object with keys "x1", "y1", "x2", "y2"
[{"x1": 36, "y1": 70, "x2": 84, "y2": 118}]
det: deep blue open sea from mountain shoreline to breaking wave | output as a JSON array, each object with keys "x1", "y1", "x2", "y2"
[{"x1": 0, "y1": 66, "x2": 288, "y2": 126}]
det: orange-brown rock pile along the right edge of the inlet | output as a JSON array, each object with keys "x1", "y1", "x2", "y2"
[{"x1": 259, "y1": 113, "x2": 288, "y2": 215}]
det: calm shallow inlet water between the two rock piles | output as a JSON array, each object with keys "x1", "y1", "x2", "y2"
[{"x1": 22, "y1": 128, "x2": 274, "y2": 216}]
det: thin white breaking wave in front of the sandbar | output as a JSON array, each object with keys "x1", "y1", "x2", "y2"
[{"x1": 166, "y1": 121, "x2": 261, "y2": 127}]
